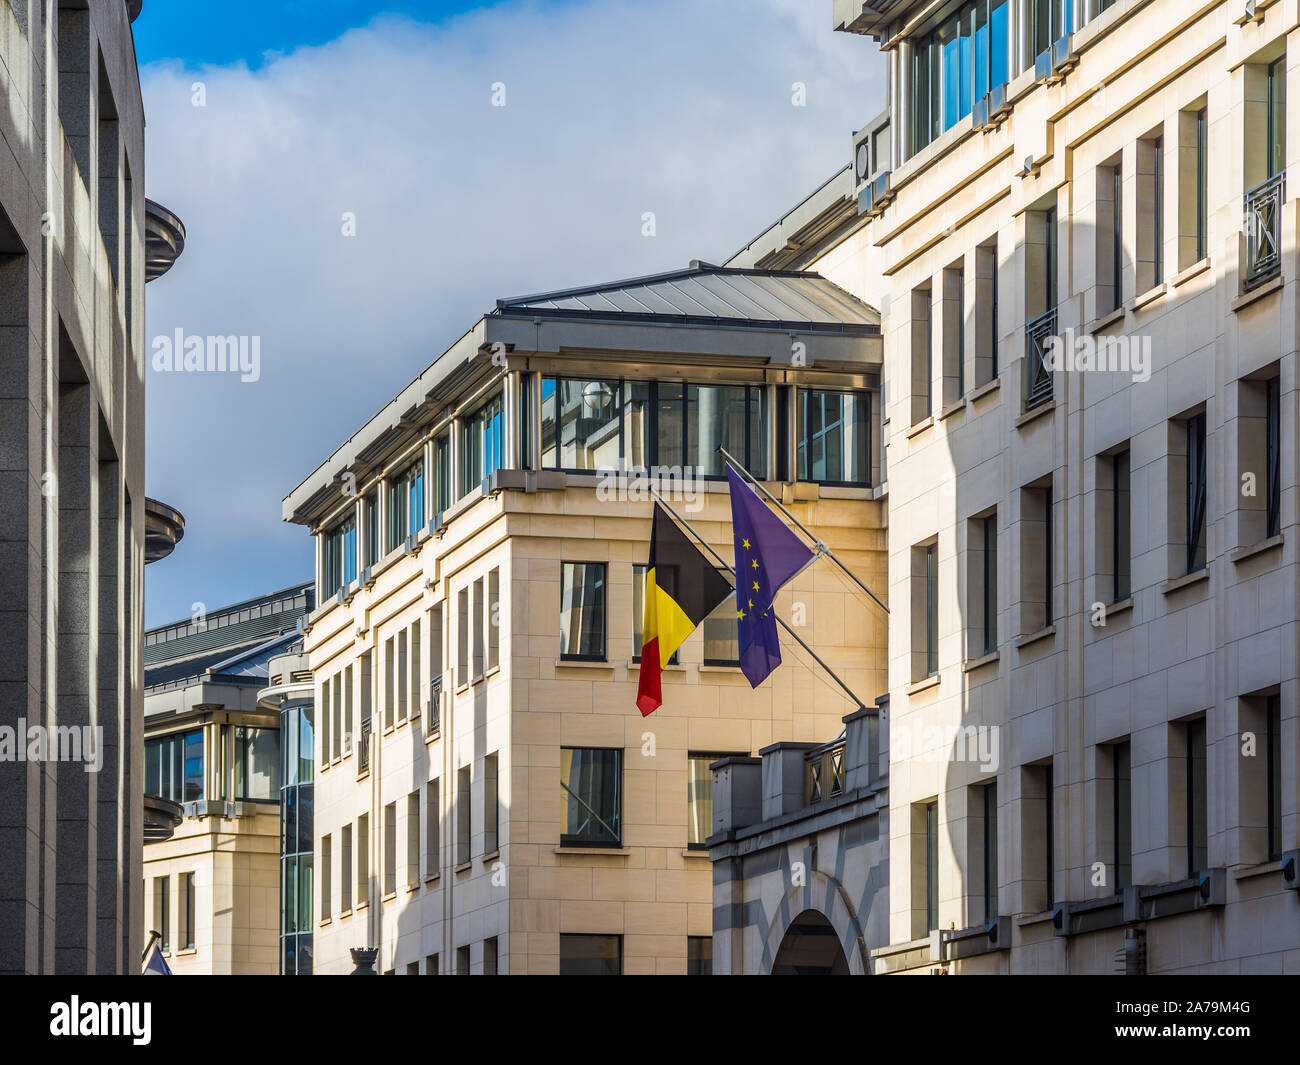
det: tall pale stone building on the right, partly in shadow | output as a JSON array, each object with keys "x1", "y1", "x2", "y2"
[{"x1": 731, "y1": 0, "x2": 1300, "y2": 973}]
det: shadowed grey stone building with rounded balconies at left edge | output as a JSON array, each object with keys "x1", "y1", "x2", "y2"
[{"x1": 0, "y1": 0, "x2": 183, "y2": 974}]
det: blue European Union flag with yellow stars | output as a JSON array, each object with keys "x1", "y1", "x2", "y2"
[{"x1": 727, "y1": 467, "x2": 813, "y2": 688}]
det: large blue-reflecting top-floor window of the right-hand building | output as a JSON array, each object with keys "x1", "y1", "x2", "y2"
[{"x1": 911, "y1": 0, "x2": 1010, "y2": 155}]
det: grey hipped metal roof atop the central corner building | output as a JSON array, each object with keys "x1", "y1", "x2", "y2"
[{"x1": 494, "y1": 261, "x2": 880, "y2": 335}]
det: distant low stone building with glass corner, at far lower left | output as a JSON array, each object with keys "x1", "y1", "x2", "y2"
[{"x1": 143, "y1": 583, "x2": 316, "y2": 975}]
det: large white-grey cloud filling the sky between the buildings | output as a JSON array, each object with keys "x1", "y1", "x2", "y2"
[{"x1": 142, "y1": 0, "x2": 884, "y2": 624}]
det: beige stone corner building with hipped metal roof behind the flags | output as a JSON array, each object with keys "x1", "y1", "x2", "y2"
[{"x1": 283, "y1": 263, "x2": 885, "y2": 974}]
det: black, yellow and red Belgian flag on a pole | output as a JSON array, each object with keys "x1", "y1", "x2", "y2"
[{"x1": 637, "y1": 503, "x2": 732, "y2": 717}]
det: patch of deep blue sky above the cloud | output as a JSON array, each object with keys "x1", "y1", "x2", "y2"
[{"x1": 135, "y1": 0, "x2": 506, "y2": 68}]
